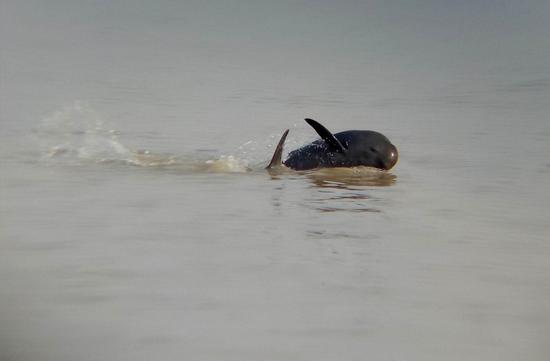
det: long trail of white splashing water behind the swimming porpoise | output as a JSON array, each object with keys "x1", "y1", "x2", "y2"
[{"x1": 35, "y1": 101, "x2": 251, "y2": 173}]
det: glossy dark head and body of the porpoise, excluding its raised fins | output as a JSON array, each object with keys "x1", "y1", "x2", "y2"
[{"x1": 283, "y1": 130, "x2": 398, "y2": 170}]
